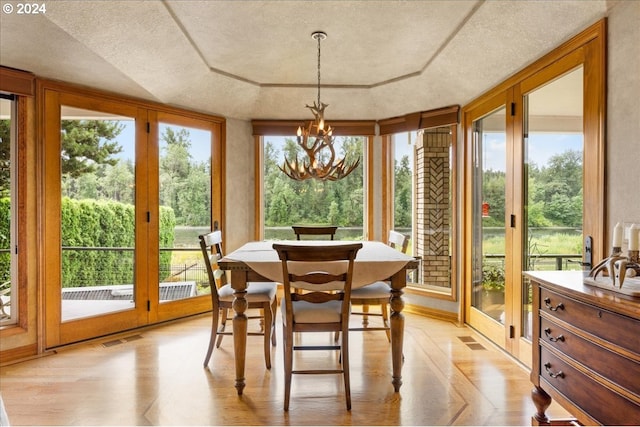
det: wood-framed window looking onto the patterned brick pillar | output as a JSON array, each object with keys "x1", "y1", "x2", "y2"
[{"x1": 380, "y1": 106, "x2": 458, "y2": 300}]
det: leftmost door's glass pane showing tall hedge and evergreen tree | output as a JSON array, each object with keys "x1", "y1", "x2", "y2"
[{"x1": 60, "y1": 105, "x2": 136, "y2": 322}]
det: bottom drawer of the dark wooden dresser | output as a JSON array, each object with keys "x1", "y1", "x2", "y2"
[{"x1": 540, "y1": 347, "x2": 640, "y2": 425}]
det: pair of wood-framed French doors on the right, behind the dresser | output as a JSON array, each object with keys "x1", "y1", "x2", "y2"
[{"x1": 463, "y1": 22, "x2": 604, "y2": 364}]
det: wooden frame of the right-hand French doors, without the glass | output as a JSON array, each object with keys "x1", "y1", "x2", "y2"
[{"x1": 461, "y1": 19, "x2": 608, "y2": 363}]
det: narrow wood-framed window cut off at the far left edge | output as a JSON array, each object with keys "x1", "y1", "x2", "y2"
[{"x1": 0, "y1": 67, "x2": 36, "y2": 338}]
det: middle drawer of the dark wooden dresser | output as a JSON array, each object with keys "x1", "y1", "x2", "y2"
[{"x1": 540, "y1": 319, "x2": 640, "y2": 396}]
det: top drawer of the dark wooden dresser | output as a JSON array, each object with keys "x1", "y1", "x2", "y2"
[{"x1": 540, "y1": 288, "x2": 640, "y2": 354}]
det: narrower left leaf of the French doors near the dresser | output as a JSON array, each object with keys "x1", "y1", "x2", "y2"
[{"x1": 467, "y1": 100, "x2": 512, "y2": 343}]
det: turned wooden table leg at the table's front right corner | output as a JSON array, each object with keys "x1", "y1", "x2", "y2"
[{"x1": 389, "y1": 268, "x2": 407, "y2": 392}]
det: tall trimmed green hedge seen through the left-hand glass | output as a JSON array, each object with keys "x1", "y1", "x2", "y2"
[{"x1": 0, "y1": 197, "x2": 176, "y2": 287}]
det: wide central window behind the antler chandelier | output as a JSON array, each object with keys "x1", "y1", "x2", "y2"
[{"x1": 252, "y1": 120, "x2": 375, "y2": 240}]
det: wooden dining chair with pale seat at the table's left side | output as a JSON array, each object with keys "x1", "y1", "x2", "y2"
[{"x1": 199, "y1": 230, "x2": 278, "y2": 369}]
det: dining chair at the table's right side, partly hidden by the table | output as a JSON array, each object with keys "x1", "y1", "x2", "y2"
[{"x1": 348, "y1": 230, "x2": 409, "y2": 342}]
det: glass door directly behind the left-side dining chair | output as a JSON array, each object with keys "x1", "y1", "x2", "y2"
[{"x1": 152, "y1": 113, "x2": 220, "y2": 320}]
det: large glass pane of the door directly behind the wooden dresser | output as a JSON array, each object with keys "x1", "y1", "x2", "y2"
[{"x1": 522, "y1": 66, "x2": 591, "y2": 340}]
